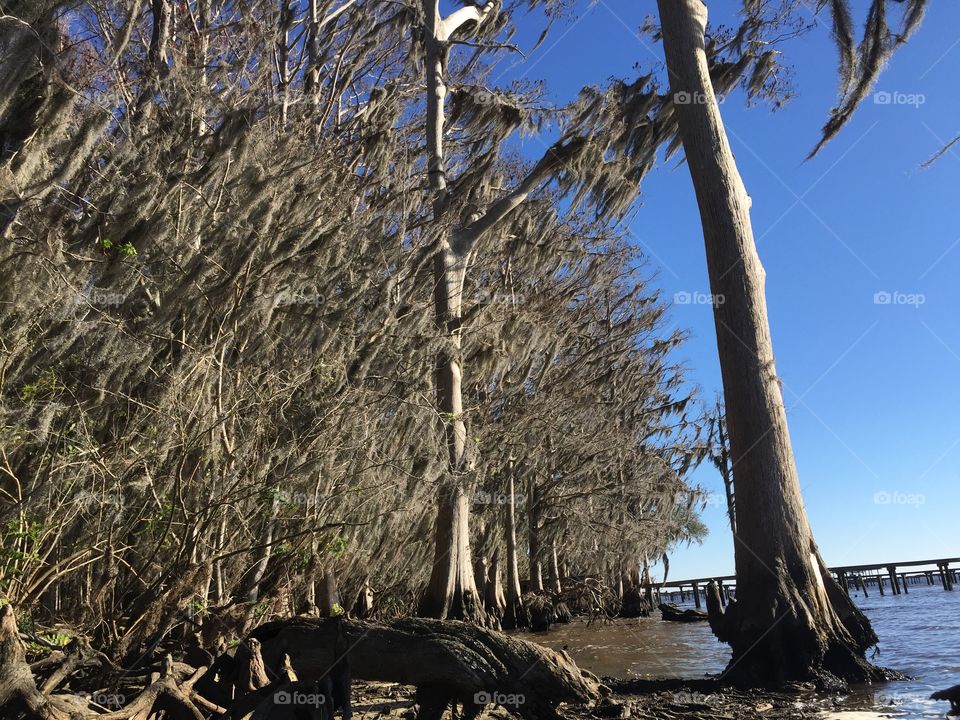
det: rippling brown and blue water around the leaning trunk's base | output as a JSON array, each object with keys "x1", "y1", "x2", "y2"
[{"x1": 525, "y1": 584, "x2": 960, "y2": 718}]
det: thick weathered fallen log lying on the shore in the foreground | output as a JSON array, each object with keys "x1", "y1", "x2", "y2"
[{"x1": 235, "y1": 618, "x2": 603, "y2": 720}]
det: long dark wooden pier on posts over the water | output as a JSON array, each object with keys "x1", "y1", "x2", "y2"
[{"x1": 659, "y1": 558, "x2": 960, "y2": 608}]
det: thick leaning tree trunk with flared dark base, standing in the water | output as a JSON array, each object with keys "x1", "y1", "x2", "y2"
[{"x1": 658, "y1": 0, "x2": 879, "y2": 683}]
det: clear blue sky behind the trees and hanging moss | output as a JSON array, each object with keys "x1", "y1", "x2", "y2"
[{"x1": 492, "y1": 0, "x2": 960, "y2": 578}]
